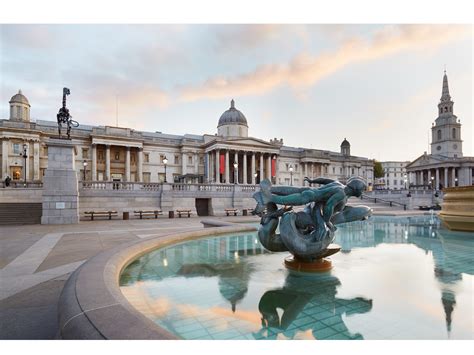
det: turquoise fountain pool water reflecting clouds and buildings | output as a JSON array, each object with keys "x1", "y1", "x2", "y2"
[{"x1": 120, "y1": 217, "x2": 474, "y2": 339}]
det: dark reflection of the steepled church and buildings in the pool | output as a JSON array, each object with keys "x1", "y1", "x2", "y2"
[{"x1": 336, "y1": 217, "x2": 474, "y2": 337}]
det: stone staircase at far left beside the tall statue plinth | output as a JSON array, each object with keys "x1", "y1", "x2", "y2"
[{"x1": 0, "y1": 203, "x2": 43, "y2": 225}]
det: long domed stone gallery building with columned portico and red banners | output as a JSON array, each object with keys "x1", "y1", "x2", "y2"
[{"x1": 0, "y1": 91, "x2": 374, "y2": 187}]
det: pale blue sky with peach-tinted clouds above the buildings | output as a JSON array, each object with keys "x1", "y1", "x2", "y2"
[{"x1": 0, "y1": 24, "x2": 474, "y2": 161}]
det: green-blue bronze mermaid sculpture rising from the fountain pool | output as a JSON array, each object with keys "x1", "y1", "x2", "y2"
[{"x1": 253, "y1": 177, "x2": 372, "y2": 271}]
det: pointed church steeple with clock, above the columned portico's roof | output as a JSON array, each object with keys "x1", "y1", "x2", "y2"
[{"x1": 431, "y1": 70, "x2": 462, "y2": 158}]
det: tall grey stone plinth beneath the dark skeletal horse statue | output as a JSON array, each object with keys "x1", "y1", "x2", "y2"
[{"x1": 41, "y1": 139, "x2": 79, "y2": 224}]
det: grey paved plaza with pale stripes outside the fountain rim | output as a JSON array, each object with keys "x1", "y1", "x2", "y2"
[{"x1": 0, "y1": 217, "x2": 258, "y2": 339}]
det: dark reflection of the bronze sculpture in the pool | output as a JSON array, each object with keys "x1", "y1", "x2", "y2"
[{"x1": 255, "y1": 273, "x2": 372, "y2": 339}]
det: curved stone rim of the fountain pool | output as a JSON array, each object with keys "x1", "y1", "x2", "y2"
[{"x1": 58, "y1": 220, "x2": 257, "y2": 340}]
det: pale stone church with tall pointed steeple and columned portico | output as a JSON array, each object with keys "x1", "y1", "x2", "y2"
[{"x1": 406, "y1": 71, "x2": 474, "y2": 189}]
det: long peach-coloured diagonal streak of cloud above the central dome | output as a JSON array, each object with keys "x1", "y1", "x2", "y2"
[{"x1": 178, "y1": 25, "x2": 471, "y2": 101}]
